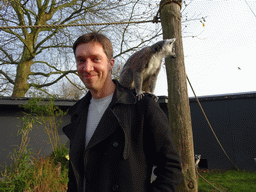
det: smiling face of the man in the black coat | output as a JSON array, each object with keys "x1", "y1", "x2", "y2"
[{"x1": 76, "y1": 42, "x2": 114, "y2": 92}]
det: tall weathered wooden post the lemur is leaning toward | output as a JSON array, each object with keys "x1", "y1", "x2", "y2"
[{"x1": 160, "y1": 0, "x2": 198, "y2": 192}]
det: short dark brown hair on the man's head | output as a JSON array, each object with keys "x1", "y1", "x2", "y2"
[{"x1": 73, "y1": 32, "x2": 113, "y2": 60}]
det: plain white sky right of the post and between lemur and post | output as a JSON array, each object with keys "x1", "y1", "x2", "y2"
[{"x1": 155, "y1": 0, "x2": 256, "y2": 97}]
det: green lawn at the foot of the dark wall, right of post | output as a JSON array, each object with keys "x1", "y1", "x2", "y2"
[{"x1": 198, "y1": 170, "x2": 256, "y2": 192}]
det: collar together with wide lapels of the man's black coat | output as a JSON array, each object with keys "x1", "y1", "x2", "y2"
[{"x1": 67, "y1": 80, "x2": 136, "y2": 159}]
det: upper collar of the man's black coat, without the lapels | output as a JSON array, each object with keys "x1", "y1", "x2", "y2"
[{"x1": 69, "y1": 79, "x2": 136, "y2": 116}]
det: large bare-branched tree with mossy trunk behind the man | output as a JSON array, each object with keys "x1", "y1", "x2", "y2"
[{"x1": 0, "y1": 0, "x2": 160, "y2": 97}]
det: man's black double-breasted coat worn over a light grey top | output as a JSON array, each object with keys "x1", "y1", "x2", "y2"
[{"x1": 63, "y1": 81, "x2": 181, "y2": 192}]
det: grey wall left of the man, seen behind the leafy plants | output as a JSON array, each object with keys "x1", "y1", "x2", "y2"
[{"x1": 0, "y1": 100, "x2": 71, "y2": 171}]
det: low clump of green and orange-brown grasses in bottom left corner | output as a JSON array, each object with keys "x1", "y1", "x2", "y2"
[{"x1": 0, "y1": 154, "x2": 68, "y2": 192}]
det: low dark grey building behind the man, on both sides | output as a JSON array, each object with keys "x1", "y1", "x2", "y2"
[{"x1": 0, "y1": 93, "x2": 256, "y2": 171}]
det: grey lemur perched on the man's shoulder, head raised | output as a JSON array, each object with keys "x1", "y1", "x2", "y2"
[{"x1": 119, "y1": 38, "x2": 176, "y2": 101}]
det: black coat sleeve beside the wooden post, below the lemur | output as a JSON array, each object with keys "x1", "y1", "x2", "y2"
[{"x1": 143, "y1": 97, "x2": 181, "y2": 192}]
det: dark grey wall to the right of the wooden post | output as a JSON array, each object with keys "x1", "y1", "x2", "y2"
[{"x1": 190, "y1": 94, "x2": 256, "y2": 171}]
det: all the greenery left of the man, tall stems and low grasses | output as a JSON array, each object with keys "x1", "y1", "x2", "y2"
[{"x1": 0, "y1": 99, "x2": 68, "y2": 192}]
